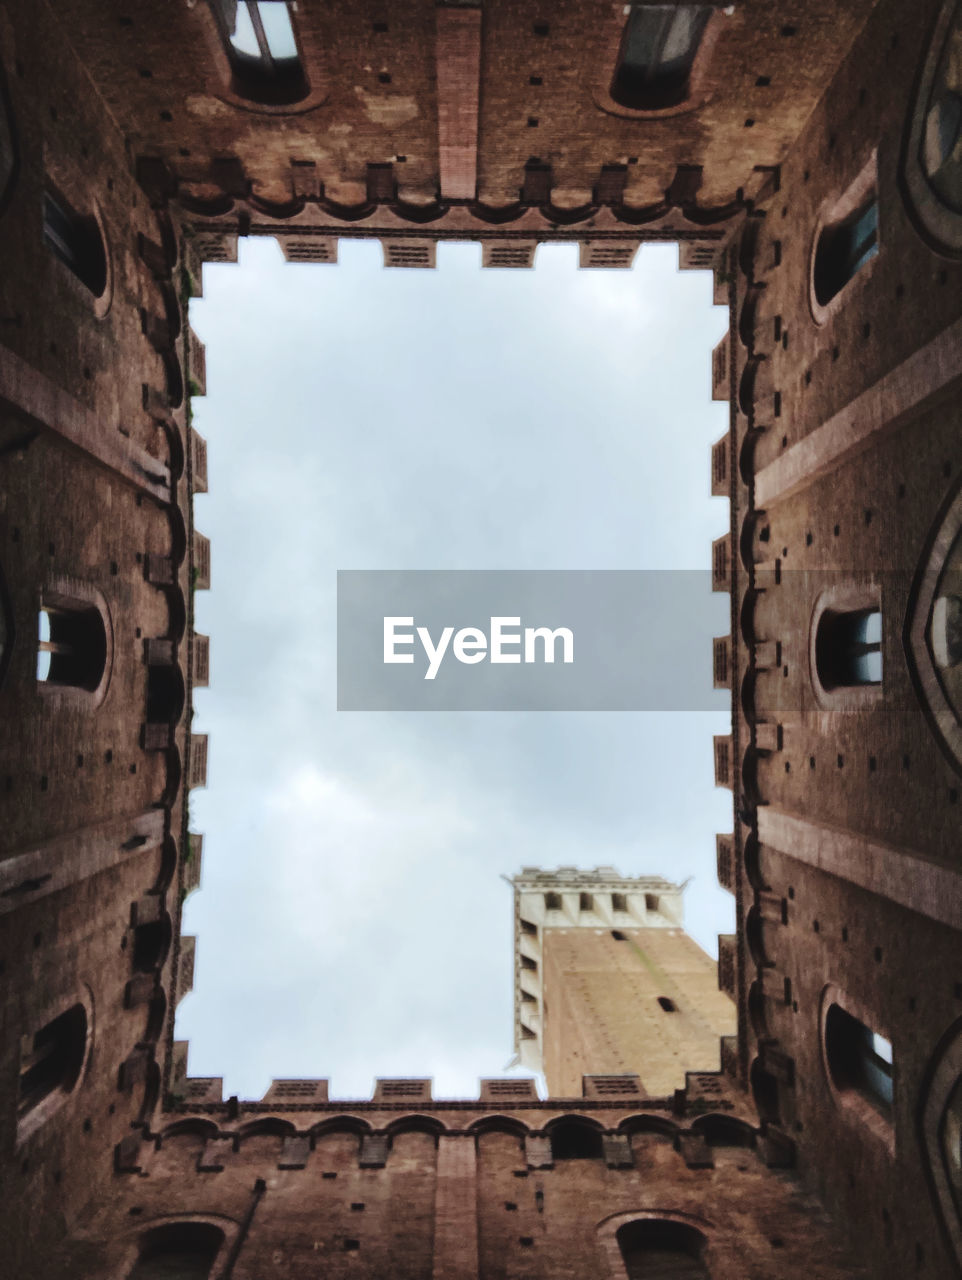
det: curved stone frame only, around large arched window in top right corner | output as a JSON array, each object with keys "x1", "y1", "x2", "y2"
[{"x1": 898, "y1": 0, "x2": 962, "y2": 257}]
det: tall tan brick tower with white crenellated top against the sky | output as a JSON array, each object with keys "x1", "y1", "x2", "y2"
[{"x1": 512, "y1": 867, "x2": 736, "y2": 1097}]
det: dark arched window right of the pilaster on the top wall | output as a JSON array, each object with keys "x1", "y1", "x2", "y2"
[{"x1": 610, "y1": 4, "x2": 713, "y2": 111}]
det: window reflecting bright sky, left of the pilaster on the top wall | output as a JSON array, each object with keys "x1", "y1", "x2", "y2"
[{"x1": 211, "y1": 0, "x2": 308, "y2": 106}]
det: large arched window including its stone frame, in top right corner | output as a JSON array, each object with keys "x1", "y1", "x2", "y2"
[{"x1": 899, "y1": 0, "x2": 962, "y2": 257}]
